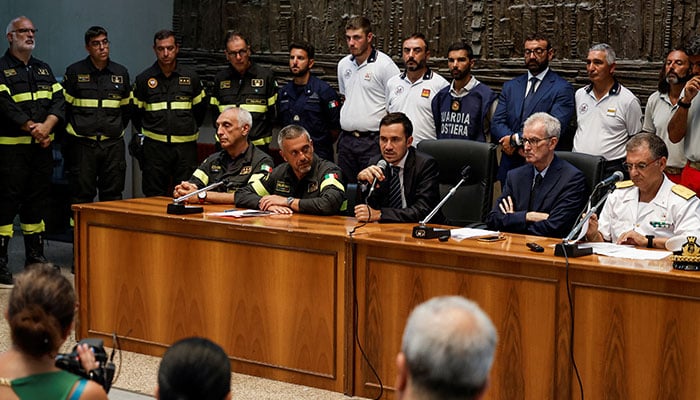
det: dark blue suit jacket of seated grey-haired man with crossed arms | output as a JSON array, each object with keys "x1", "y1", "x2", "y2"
[{"x1": 486, "y1": 156, "x2": 588, "y2": 238}]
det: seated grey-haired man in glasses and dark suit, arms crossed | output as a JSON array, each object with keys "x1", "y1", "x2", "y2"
[{"x1": 486, "y1": 113, "x2": 588, "y2": 238}]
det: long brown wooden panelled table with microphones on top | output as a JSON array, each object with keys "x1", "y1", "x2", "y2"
[{"x1": 74, "y1": 198, "x2": 700, "y2": 399}]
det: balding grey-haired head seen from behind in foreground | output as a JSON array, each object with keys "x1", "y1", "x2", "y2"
[{"x1": 396, "y1": 296, "x2": 498, "y2": 400}]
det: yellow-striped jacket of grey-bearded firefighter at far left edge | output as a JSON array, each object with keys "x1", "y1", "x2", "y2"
[{"x1": 0, "y1": 50, "x2": 65, "y2": 144}]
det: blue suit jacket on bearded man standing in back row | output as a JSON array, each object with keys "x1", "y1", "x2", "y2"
[{"x1": 491, "y1": 69, "x2": 576, "y2": 183}]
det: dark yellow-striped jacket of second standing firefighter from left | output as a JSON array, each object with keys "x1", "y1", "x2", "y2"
[{"x1": 63, "y1": 57, "x2": 131, "y2": 138}]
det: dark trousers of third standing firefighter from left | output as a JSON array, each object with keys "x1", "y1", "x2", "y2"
[{"x1": 141, "y1": 138, "x2": 197, "y2": 197}]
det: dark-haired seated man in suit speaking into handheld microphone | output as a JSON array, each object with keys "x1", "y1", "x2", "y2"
[{"x1": 355, "y1": 112, "x2": 442, "y2": 223}]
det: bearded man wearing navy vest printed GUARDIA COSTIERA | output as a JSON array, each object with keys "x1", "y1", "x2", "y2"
[{"x1": 432, "y1": 42, "x2": 496, "y2": 142}]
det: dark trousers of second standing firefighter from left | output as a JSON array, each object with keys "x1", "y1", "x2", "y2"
[{"x1": 64, "y1": 137, "x2": 126, "y2": 204}]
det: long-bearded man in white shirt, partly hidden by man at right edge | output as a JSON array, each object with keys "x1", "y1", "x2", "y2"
[{"x1": 642, "y1": 49, "x2": 691, "y2": 183}]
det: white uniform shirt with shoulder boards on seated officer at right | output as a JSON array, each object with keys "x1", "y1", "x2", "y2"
[{"x1": 598, "y1": 175, "x2": 700, "y2": 242}]
